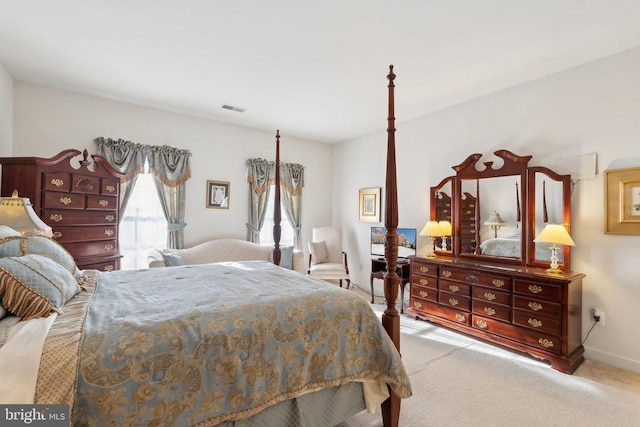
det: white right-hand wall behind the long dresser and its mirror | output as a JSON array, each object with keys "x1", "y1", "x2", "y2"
[{"x1": 334, "y1": 49, "x2": 640, "y2": 372}]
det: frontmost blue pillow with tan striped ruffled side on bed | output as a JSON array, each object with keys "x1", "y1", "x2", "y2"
[{"x1": 0, "y1": 254, "x2": 80, "y2": 320}]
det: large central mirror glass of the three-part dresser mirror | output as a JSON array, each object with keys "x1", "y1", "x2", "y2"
[{"x1": 460, "y1": 175, "x2": 523, "y2": 259}]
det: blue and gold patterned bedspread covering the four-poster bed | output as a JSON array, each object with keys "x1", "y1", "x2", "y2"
[{"x1": 36, "y1": 261, "x2": 411, "y2": 425}]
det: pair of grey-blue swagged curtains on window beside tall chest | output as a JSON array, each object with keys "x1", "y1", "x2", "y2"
[{"x1": 94, "y1": 137, "x2": 191, "y2": 249}]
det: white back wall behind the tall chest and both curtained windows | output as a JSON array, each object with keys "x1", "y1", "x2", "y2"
[{"x1": 11, "y1": 82, "x2": 332, "y2": 248}]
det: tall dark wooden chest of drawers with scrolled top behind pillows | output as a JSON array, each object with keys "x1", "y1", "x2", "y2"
[{"x1": 0, "y1": 150, "x2": 122, "y2": 271}]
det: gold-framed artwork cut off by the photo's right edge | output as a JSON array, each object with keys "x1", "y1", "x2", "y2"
[{"x1": 604, "y1": 168, "x2": 640, "y2": 234}]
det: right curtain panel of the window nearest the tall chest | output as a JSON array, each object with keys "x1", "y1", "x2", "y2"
[{"x1": 148, "y1": 145, "x2": 191, "y2": 249}]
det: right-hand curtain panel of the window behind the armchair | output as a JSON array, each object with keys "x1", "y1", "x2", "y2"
[{"x1": 280, "y1": 163, "x2": 304, "y2": 249}]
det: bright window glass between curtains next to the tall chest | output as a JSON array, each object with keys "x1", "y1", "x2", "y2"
[{"x1": 119, "y1": 173, "x2": 167, "y2": 270}]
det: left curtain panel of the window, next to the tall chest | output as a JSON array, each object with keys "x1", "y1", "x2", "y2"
[{"x1": 95, "y1": 137, "x2": 149, "y2": 213}]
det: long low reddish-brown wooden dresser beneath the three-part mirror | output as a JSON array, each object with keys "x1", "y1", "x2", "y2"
[{"x1": 407, "y1": 257, "x2": 584, "y2": 373}]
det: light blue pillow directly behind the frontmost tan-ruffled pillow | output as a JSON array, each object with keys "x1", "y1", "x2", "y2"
[{"x1": 0, "y1": 234, "x2": 80, "y2": 277}]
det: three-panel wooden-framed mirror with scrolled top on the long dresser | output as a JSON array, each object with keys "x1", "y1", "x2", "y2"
[{"x1": 431, "y1": 150, "x2": 571, "y2": 269}]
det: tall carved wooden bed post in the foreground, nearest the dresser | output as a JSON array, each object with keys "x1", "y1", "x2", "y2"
[{"x1": 381, "y1": 65, "x2": 400, "y2": 427}]
